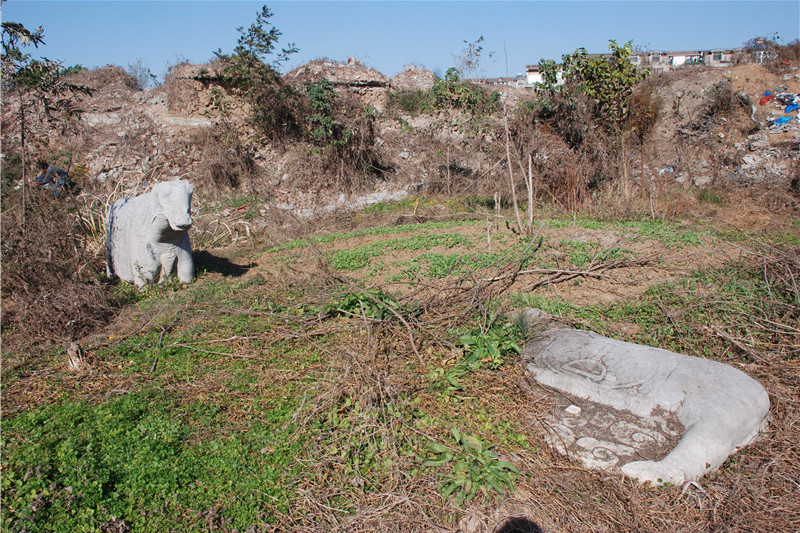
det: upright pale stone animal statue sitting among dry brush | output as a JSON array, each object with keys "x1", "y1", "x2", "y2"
[{"x1": 106, "y1": 180, "x2": 194, "y2": 287}]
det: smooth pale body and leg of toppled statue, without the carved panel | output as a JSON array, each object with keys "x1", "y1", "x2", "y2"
[{"x1": 523, "y1": 318, "x2": 769, "y2": 484}]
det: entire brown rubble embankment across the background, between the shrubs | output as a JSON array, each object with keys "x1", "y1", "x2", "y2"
[{"x1": 7, "y1": 58, "x2": 800, "y2": 220}]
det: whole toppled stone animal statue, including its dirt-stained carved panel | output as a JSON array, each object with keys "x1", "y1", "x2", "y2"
[{"x1": 523, "y1": 318, "x2": 769, "y2": 484}]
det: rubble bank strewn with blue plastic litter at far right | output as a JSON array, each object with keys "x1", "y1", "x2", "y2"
[{"x1": 631, "y1": 64, "x2": 800, "y2": 188}]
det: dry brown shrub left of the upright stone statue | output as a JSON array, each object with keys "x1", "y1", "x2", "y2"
[{"x1": 2, "y1": 190, "x2": 112, "y2": 344}]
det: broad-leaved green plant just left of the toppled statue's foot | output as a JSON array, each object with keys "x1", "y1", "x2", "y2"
[{"x1": 422, "y1": 426, "x2": 519, "y2": 506}]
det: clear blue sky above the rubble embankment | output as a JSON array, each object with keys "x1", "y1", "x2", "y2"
[{"x1": 0, "y1": 0, "x2": 800, "y2": 80}]
